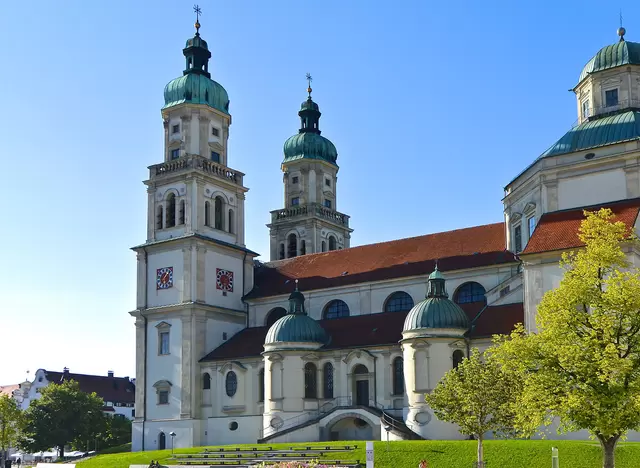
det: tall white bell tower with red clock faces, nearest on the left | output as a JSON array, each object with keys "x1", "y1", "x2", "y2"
[{"x1": 130, "y1": 7, "x2": 257, "y2": 451}]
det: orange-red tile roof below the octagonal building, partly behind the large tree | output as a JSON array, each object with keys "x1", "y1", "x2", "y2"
[{"x1": 521, "y1": 198, "x2": 640, "y2": 255}]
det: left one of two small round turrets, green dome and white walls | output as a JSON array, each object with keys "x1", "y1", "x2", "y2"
[{"x1": 262, "y1": 281, "x2": 329, "y2": 436}]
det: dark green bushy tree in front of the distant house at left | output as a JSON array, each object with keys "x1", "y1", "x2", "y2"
[{"x1": 20, "y1": 381, "x2": 105, "y2": 456}]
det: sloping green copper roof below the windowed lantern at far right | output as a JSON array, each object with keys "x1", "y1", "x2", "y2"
[{"x1": 540, "y1": 110, "x2": 640, "y2": 158}]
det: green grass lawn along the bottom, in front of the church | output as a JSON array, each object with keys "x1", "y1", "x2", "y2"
[{"x1": 78, "y1": 440, "x2": 640, "y2": 468}]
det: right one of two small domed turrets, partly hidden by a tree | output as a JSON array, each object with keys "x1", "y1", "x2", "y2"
[{"x1": 401, "y1": 265, "x2": 469, "y2": 439}]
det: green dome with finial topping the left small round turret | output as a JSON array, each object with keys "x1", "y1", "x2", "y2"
[{"x1": 264, "y1": 286, "x2": 329, "y2": 345}]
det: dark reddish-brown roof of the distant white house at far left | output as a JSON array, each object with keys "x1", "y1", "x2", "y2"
[{"x1": 45, "y1": 371, "x2": 136, "y2": 403}]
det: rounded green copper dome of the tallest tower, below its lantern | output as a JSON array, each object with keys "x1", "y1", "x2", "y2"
[{"x1": 163, "y1": 73, "x2": 229, "y2": 114}]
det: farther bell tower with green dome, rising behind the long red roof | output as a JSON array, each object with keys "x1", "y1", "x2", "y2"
[{"x1": 267, "y1": 74, "x2": 353, "y2": 260}]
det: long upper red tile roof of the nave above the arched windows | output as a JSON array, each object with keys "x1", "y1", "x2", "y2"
[{"x1": 247, "y1": 223, "x2": 516, "y2": 298}]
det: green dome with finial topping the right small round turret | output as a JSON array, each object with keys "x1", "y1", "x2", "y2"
[{"x1": 403, "y1": 266, "x2": 469, "y2": 332}]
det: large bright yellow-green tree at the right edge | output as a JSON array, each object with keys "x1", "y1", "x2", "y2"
[{"x1": 495, "y1": 209, "x2": 640, "y2": 467}]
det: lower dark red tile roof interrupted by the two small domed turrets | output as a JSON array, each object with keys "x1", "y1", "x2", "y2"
[{"x1": 201, "y1": 303, "x2": 524, "y2": 362}]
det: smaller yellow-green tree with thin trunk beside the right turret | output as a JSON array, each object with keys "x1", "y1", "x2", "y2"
[{"x1": 425, "y1": 349, "x2": 520, "y2": 463}]
